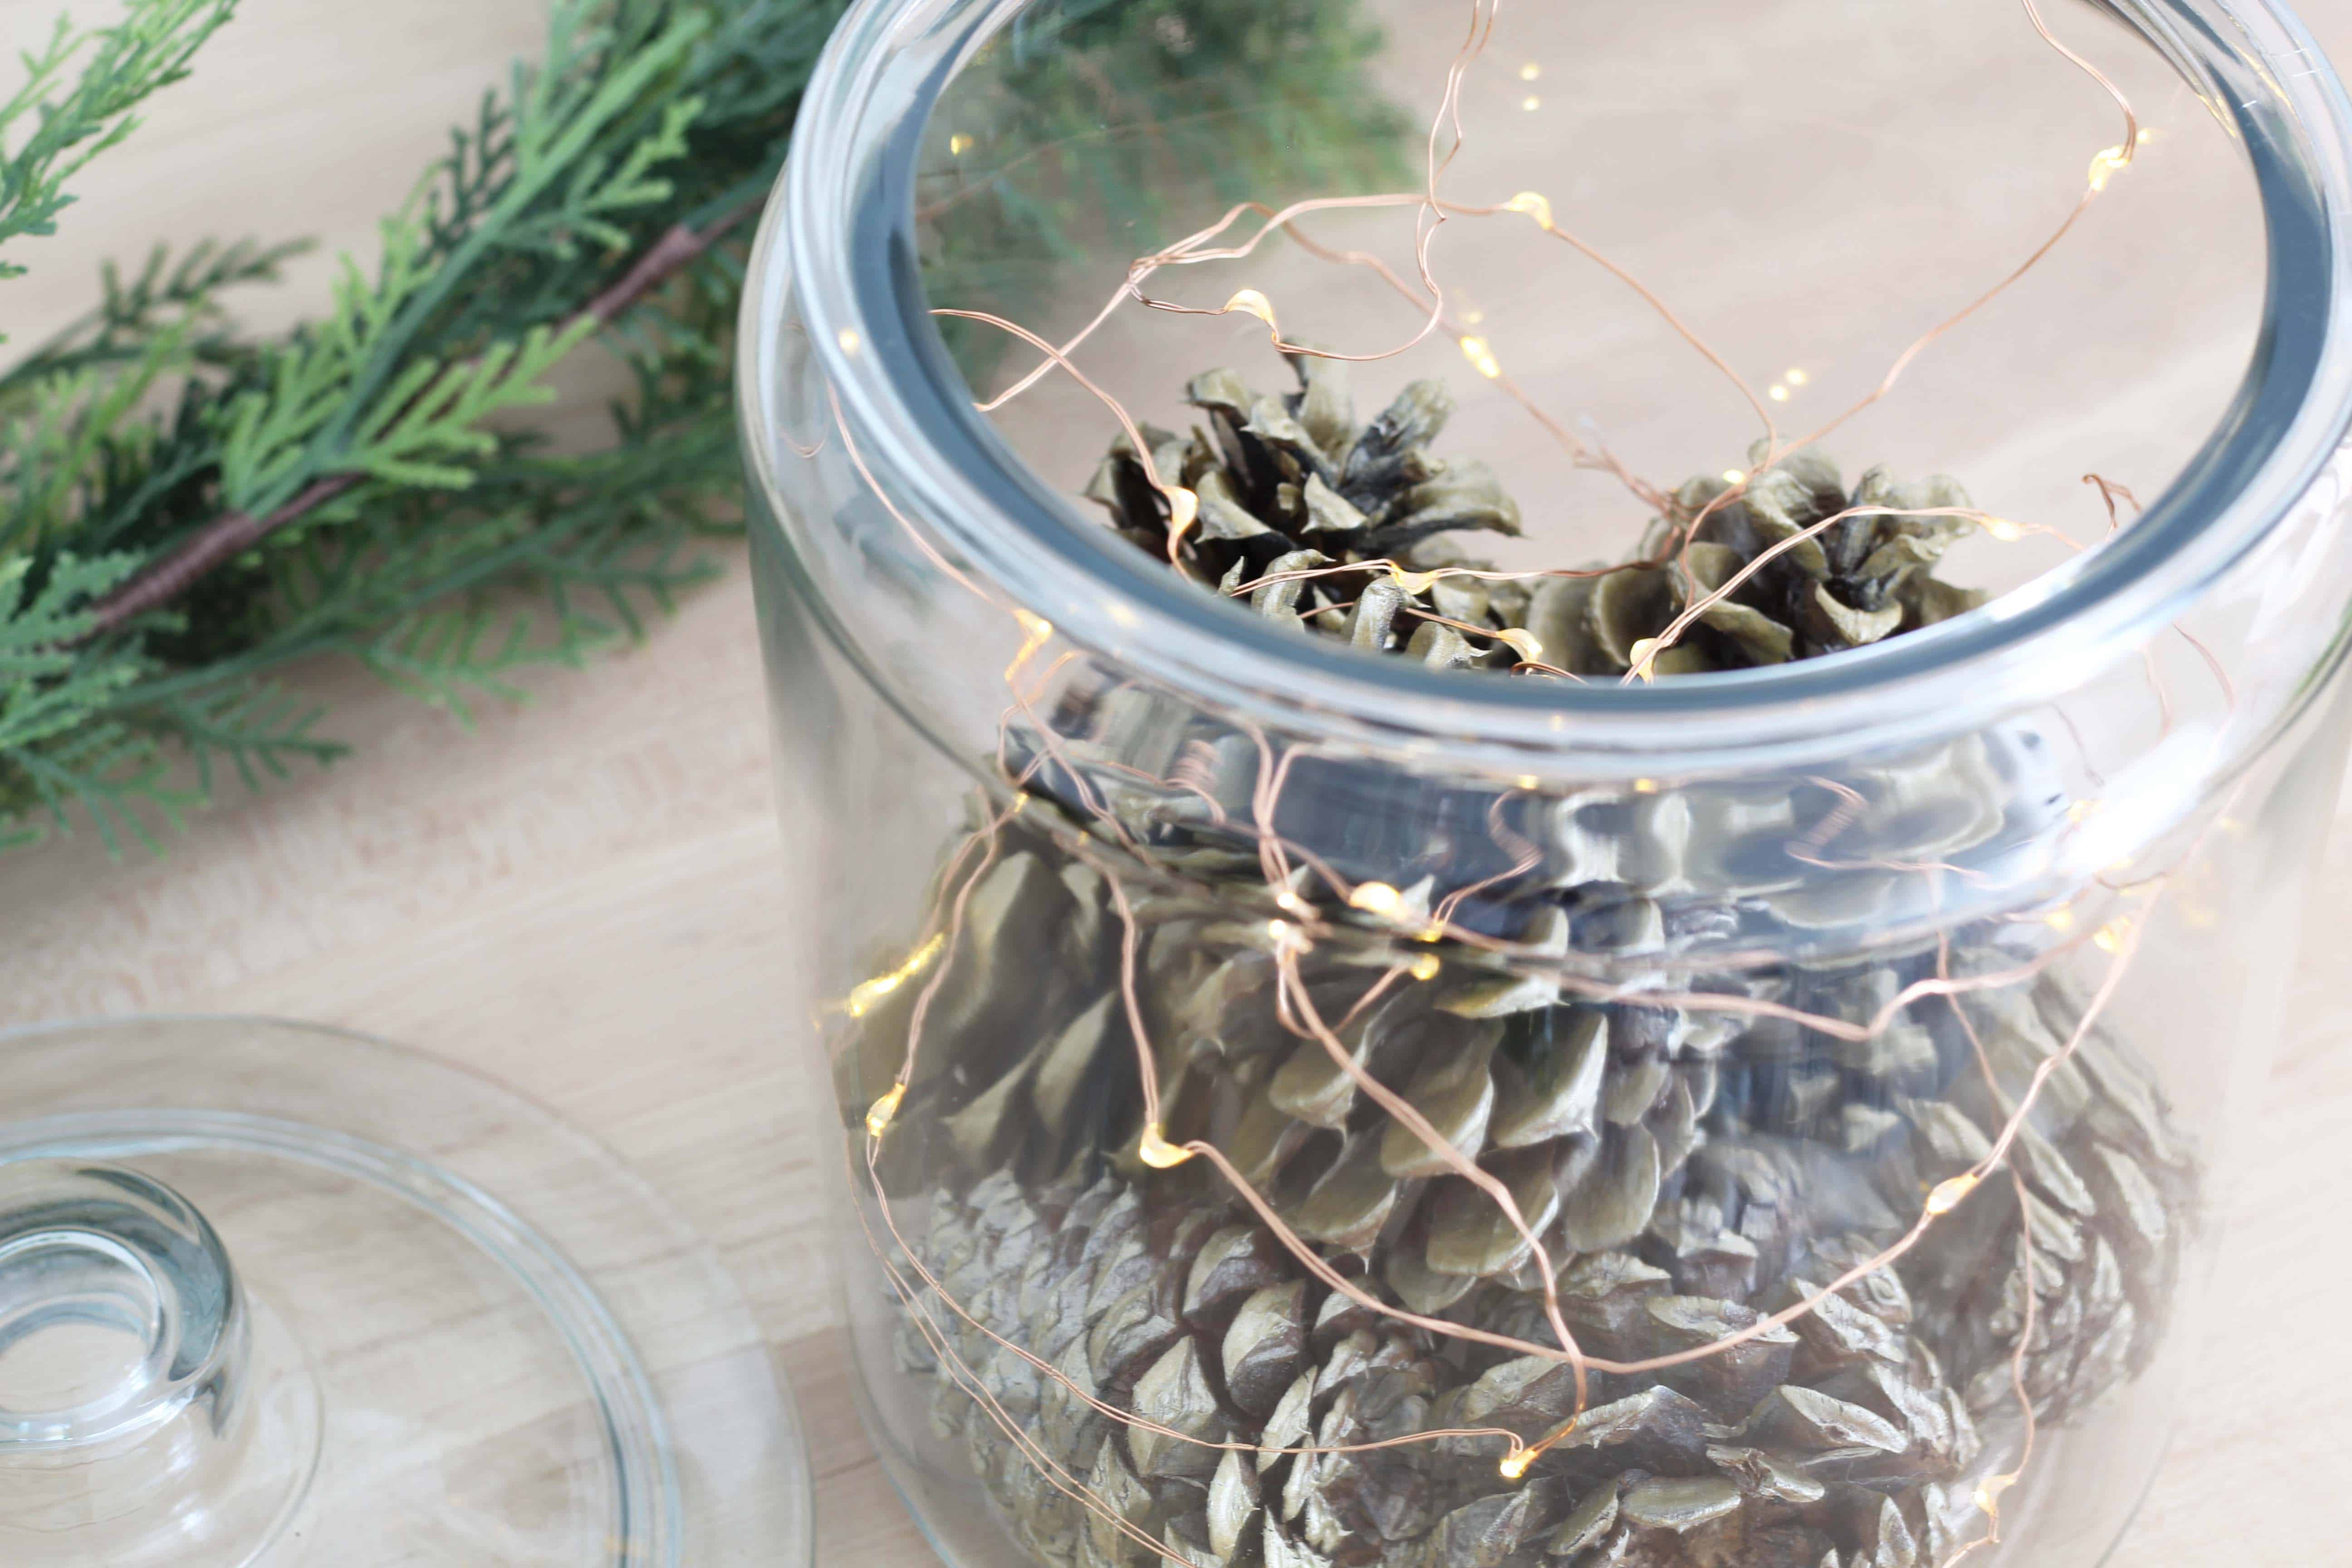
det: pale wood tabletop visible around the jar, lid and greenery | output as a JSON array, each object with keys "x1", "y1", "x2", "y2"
[{"x1": 0, "y1": 0, "x2": 2352, "y2": 1568}]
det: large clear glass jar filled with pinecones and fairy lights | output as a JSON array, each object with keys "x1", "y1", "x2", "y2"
[{"x1": 741, "y1": 0, "x2": 2352, "y2": 1568}]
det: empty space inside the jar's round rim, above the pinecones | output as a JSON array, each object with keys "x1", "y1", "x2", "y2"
[{"x1": 915, "y1": 0, "x2": 2267, "y2": 644}]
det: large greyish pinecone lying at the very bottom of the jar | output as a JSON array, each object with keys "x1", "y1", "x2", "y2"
[{"x1": 910, "y1": 1176, "x2": 1983, "y2": 1568}]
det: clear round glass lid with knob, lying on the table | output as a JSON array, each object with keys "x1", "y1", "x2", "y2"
[{"x1": 0, "y1": 1018, "x2": 811, "y2": 1568}]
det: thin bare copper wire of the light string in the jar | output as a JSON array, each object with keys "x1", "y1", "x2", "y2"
[{"x1": 833, "y1": 0, "x2": 2234, "y2": 1533}]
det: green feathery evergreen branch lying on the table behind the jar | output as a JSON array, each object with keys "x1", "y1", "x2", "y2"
[{"x1": 0, "y1": 0, "x2": 1385, "y2": 846}]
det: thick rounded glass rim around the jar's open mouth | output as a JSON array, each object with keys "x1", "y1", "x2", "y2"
[{"x1": 739, "y1": 0, "x2": 2352, "y2": 774}]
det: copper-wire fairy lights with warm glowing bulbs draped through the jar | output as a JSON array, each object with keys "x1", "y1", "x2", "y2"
[{"x1": 795, "y1": 0, "x2": 2234, "y2": 1563}]
